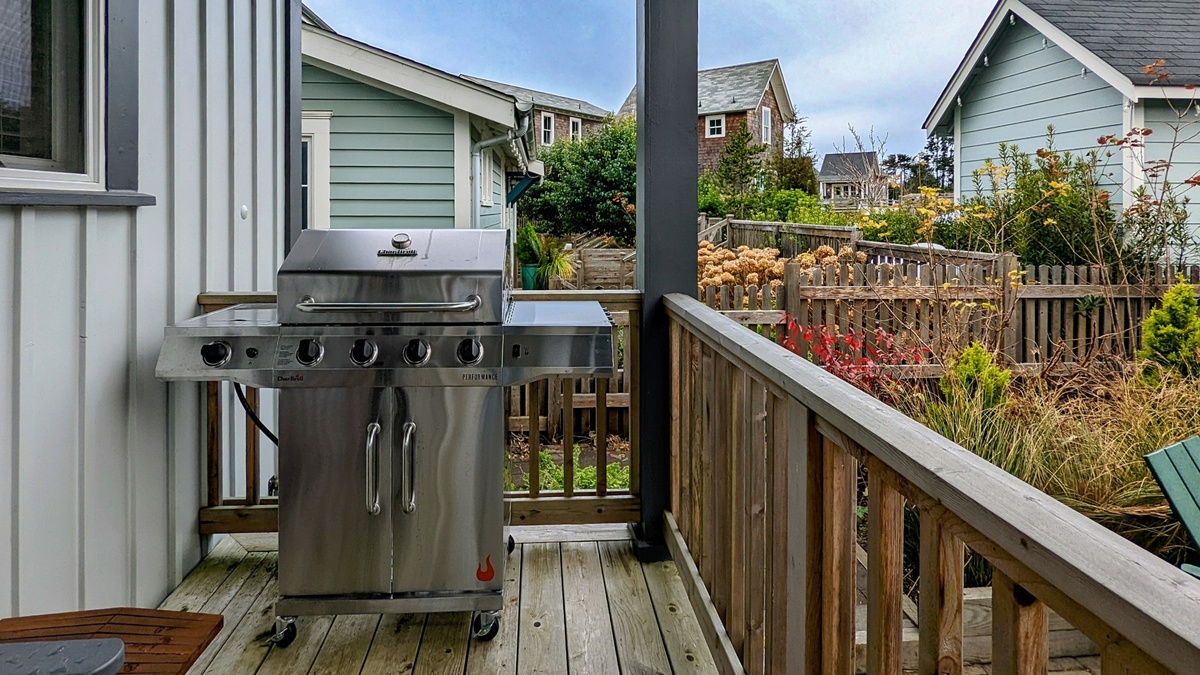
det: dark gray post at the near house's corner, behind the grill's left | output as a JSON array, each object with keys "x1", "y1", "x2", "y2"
[{"x1": 283, "y1": 0, "x2": 304, "y2": 255}]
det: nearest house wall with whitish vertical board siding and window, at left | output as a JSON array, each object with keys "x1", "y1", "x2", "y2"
[{"x1": 0, "y1": 0, "x2": 300, "y2": 614}]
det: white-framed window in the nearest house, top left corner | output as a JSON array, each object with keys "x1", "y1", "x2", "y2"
[{"x1": 0, "y1": 0, "x2": 102, "y2": 189}]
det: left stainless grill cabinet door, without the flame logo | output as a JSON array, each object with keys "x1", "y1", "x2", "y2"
[{"x1": 280, "y1": 387, "x2": 395, "y2": 596}]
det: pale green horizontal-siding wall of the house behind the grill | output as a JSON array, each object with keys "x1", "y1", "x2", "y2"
[{"x1": 302, "y1": 64, "x2": 455, "y2": 228}]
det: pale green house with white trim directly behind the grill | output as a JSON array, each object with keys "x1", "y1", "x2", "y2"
[{"x1": 302, "y1": 12, "x2": 542, "y2": 228}]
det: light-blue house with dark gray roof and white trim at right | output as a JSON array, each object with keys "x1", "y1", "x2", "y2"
[{"x1": 925, "y1": 0, "x2": 1200, "y2": 234}]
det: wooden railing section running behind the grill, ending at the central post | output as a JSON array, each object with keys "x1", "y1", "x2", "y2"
[{"x1": 197, "y1": 291, "x2": 641, "y2": 534}]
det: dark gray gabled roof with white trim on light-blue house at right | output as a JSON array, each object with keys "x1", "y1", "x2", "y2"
[{"x1": 924, "y1": 0, "x2": 1200, "y2": 133}]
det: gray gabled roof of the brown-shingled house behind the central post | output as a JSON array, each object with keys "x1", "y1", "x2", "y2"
[{"x1": 618, "y1": 59, "x2": 796, "y2": 121}]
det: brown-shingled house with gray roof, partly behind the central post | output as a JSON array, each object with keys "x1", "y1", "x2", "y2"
[{"x1": 617, "y1": 59, "x2": 796, "y2": 173}]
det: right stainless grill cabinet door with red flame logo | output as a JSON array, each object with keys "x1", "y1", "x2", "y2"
[{"x1": 391, "y1": 387, "x2": 504, "y2": 593}]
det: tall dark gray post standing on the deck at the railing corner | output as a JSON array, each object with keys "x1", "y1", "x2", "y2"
[{"x1": 632, "y1": 0, "x2": 697, "y2": 562}]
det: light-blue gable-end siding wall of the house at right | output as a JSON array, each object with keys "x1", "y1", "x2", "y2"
[{"x1": 955, "y1": 19, "x2": 1124, "y2": 197}]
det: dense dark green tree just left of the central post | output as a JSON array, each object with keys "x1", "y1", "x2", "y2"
[{"x1": 521, "y1": 118, "x2": 637, "y2": 245}]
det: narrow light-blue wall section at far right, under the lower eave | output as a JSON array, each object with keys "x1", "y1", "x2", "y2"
[{"x1": 1141, "y1": 100, "x2": 1200, "y2": 246}]
